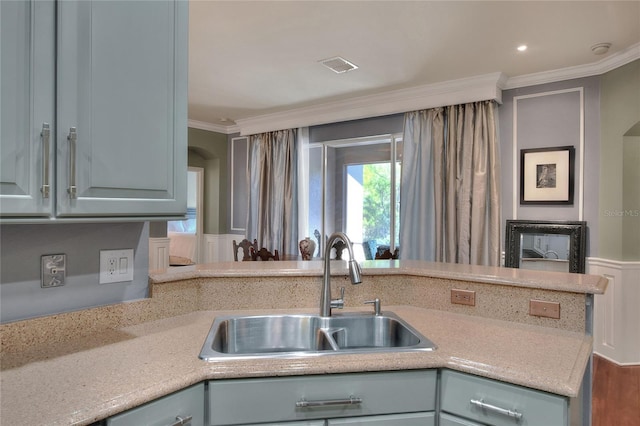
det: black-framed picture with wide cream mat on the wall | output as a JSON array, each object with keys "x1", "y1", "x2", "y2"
[{"x1": 520, "y1": 146, "x2": 575, "y2": 204}]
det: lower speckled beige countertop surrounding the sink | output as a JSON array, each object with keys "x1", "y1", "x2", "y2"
[{"x1": 0, "y1": 304, "x2": 592, "y2": 426}]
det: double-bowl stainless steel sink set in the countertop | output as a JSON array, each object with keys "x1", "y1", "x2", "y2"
[{"x1": 200, "y1": 312, "x2": 436, "y2": 361}]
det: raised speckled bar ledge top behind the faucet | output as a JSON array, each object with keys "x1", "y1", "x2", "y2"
[{"x1": 149, "y1": 260, "x2": 608, "y2": 294}]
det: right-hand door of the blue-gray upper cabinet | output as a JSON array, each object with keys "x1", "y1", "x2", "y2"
[{"x1": 57, "y1": 1, "x2": 188, "y2": 216}]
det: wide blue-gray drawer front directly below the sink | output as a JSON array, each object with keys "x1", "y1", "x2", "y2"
[{"x1": 209, "y1": 371, "x2": 436, "y2": 425}]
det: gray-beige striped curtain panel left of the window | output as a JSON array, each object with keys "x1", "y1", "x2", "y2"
[{"x1": 247, "y1": 129, "x2": 298, "y2": 255}]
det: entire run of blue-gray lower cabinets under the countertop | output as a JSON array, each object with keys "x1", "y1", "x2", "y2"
[{"x1": 101, "y1": 370, "x2": 570, "y2": 426}]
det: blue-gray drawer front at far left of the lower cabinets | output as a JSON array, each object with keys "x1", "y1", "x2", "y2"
[{"x1": 107, "y1": 383, "x2": 205, "y2": 426}]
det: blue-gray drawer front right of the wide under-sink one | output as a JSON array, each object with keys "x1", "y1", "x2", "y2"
[{"x1": 441, "y1": 370, "x2": 569, "y2": 426}]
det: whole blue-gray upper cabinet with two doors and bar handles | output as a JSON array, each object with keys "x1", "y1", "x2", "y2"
[{"x1": 0, "y1": 0, "x2": 188, "y2": 222}]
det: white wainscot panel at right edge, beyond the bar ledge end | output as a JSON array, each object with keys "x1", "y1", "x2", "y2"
[{"x1": 587, "y1": 258, "x2": 640, "y2": 365}]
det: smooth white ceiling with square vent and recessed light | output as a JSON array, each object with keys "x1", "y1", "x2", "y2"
[{"x1": 189, "y1": 0, "x2": 640, "y2": 133}]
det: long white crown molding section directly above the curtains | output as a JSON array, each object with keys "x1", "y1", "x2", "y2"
[{"x1": 236, "y1": 73, "x2": 503, "y2": 135}]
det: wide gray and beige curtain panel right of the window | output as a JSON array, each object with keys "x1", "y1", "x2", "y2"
[{"x1": 400, "y1": 101, "x2": 500, "y2": 266}]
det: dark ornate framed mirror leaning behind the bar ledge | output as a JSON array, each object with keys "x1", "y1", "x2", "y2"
[{"x1": 504, "y1": 220, "x2": 587, "y2": 274}]
